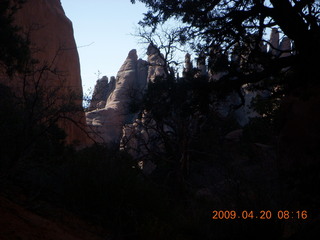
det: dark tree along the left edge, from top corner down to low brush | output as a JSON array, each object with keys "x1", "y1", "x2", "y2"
[{"x1": 0, "y1": 1, "x2": 87, "y2": 170}]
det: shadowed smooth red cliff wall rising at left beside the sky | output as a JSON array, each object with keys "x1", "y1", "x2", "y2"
[{"x1": 1, "y1": 0, "x2": 88, "y2": 146}]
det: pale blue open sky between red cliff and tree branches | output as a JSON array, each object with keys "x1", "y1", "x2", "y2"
[{"x1": 61, "y1": 0, "x2": 147, "y2": 94}]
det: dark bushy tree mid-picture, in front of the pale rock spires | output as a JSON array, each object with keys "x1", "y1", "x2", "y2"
[{"x1": 129, "y1": 73, "x2": 216, "y2": 178}]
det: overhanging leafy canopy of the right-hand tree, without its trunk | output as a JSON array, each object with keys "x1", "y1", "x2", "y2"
[{"x1": 131, "y1": 0, "x2": 320, "y2": 94}]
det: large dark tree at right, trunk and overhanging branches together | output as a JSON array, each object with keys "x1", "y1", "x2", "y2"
[{"x1": 131, "y1": 0, "x2": 320, "y2": 216}]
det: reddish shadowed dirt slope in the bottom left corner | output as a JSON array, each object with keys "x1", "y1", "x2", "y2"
[{"x1": 0, "y1": 196, "x2": 107, "y2": 240}]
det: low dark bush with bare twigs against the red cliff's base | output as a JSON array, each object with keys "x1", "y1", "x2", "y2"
[{"x1": 0, "y1": 47, "x2": 81, "y2": 171}]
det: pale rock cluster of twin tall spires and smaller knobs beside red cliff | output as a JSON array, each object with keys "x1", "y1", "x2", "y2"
[{"x1": 86, "y1": 44, "x2": 172, "y2": 144}]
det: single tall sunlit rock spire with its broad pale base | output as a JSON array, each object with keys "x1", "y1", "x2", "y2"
[{"x1": 86, "y1": 49, "x2": 148, "y2": 143}]
